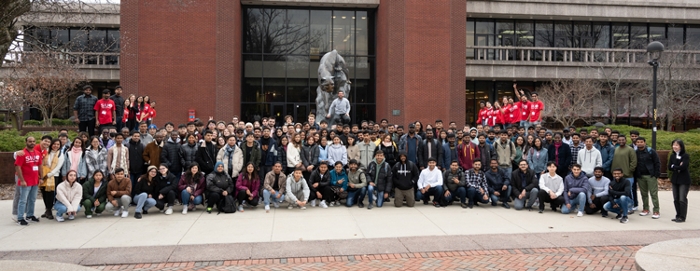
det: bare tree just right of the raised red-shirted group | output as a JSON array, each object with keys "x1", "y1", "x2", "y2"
[{"x1": 538, "y1": 79, "x2": 601, "y2": 127}]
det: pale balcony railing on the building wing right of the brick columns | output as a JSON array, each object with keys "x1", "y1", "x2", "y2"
[{"x1": 467, "y1": 46, "x2": 700, "y2": 64}]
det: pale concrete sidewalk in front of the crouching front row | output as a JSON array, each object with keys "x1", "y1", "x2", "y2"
[{"x1": 0, "y1": 191, "x2": 700, "y2": 265}]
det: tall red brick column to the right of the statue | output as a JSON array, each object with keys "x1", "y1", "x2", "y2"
[{"x1": 376, "y1": 0, "x2": 467, "y2": 125}]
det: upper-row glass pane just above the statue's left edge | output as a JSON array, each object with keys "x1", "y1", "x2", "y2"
[{"x1": 309, "y1": 10, "x2": 332, "y2": 58}]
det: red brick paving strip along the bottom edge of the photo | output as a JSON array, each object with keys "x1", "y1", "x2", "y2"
[{"x1": 95, "y1": 246, "x2": 641, "y2": 271}]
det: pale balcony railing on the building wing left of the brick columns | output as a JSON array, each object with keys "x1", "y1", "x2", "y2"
[{"x1": 3, "y1": 51, "x2": 119, "y2": 68}]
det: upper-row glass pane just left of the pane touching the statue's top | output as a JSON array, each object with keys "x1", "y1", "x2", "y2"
[{"x1": 283, "y1": 9, "x2": 309, "y2": 55}]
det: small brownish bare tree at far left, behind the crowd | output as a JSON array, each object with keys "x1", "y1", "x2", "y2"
[{"x1": 3, "y1": 54, "x2": 85, "y2": 126}]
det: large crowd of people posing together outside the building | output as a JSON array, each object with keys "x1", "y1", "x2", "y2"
[{"x1": 13, "y1": 85, "x2": 690, "y2": 225}]
